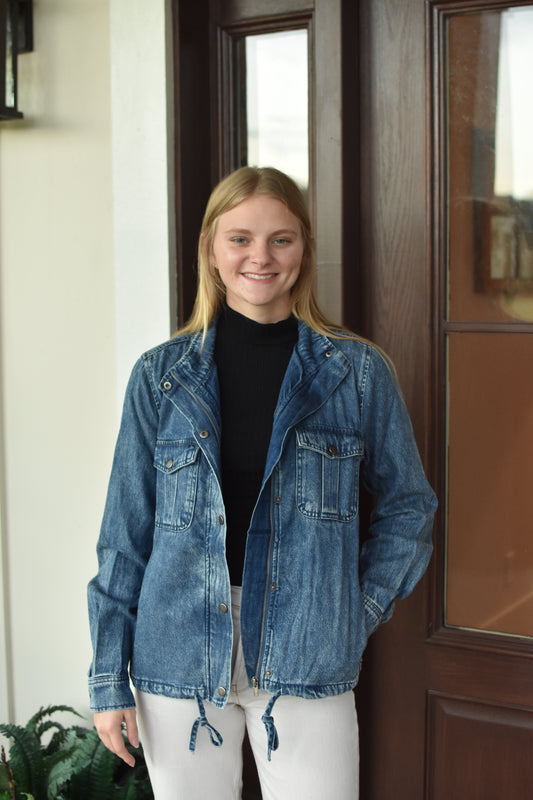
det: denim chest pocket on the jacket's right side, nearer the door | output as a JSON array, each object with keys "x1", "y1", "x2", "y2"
[{"x1": 296, "y1": 428, "x2": 363, "y2": 522}]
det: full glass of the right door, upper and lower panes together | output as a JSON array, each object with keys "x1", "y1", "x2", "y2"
[{"x1": 444, "y1": 5, "x2": 533, "y2": 636}]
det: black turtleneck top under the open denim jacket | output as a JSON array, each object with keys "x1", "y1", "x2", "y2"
[{"x1": 215, "y1": 306, "x2": 298, "y2": 586}]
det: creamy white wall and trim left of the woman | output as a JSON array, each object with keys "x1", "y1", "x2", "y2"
[{"x1": 0, "y1": 0, "x2": 170, "y2": 722}]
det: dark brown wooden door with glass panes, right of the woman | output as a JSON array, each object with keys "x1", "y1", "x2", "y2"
[{"x1": 354, "y1": 0, "x2": 533, "y2": 800}]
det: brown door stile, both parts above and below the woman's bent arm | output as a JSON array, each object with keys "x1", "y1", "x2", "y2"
[{"x1": 357, "y1": 0, "x2": 432, "y2": 800}]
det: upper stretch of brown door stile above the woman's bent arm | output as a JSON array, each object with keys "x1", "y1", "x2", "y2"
[{"x1": 360, "y1": 0, "x2": 428, "y2": 424}]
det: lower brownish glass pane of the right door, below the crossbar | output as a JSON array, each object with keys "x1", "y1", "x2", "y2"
[{"x1": 446, "y1": 333, "x2": 533, "y2": 636}]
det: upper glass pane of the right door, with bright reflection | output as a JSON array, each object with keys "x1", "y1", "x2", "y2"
[{"x1": 447, "y1": 6, "x2": 533, "y2": 322}]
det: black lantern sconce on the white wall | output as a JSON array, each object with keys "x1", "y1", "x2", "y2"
[{"x1": 0, "y1": 0, "x2": 33, "y2": 120}]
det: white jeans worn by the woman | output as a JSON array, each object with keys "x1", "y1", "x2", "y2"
[{"x1": 136, "y1": 589, "x2": 359, "y2": 800}]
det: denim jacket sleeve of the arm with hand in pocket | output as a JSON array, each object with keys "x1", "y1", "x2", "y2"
[{"x1": 360, "y1": 348, "x2": 437, "y2": 635}]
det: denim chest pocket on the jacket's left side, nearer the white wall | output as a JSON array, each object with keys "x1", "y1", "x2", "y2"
[{"x1": 154, "y1": 439, "x2": 200, "y2": 531}]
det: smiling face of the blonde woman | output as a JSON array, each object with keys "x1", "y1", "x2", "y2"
[{"x1": 211, "y1": 195, "x2": 304, "y2": 323}]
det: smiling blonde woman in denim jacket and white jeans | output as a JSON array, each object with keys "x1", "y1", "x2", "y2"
[{"x1": 89, "y1": 167, "x2": 436, "y2": 800}]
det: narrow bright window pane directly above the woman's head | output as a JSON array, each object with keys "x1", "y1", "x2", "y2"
[{"x1": 235, "y1": 29, "x2": 309, "y2": 191}]
